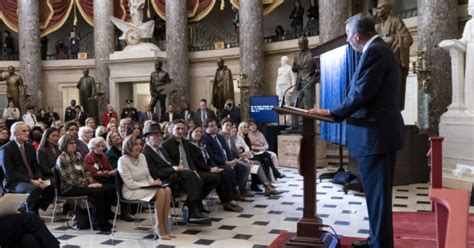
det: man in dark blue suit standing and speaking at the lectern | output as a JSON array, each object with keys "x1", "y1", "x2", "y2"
[{"x1": 309, "y1": 15, "x2": 404, "y2": 248}]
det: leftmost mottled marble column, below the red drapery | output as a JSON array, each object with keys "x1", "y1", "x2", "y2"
[{"x1": 18, "y1": 0, "x2": 43, "y2": 108}]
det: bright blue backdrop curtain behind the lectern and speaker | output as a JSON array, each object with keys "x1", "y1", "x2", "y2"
[{"x1": 320, "y1": 45, "x2": 360, "y2": 145}]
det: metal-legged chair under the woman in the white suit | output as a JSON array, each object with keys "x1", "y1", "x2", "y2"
[{"x1": 112, "y1": 171, "x2": 158, "y2": 239}]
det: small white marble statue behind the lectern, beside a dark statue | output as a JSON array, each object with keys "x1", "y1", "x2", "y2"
[{"x1": 276, "y1": 56, "x2": 296, "y2": 103}]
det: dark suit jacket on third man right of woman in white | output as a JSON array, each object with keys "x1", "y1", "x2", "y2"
[{"x1": 201, "y1": 133, "x2": 234, "y2": 167}]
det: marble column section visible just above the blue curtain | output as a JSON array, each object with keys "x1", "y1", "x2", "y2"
[{"x1": 319, "y1": 0, "x2": 350, "y2": 44}]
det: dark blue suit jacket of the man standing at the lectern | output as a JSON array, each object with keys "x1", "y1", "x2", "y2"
[{"x1": 329, "y1": 38, "x2": 404, "y2": 156}]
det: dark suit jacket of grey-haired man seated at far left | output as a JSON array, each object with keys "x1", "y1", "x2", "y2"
[{"x1": 2, "y1": 140, "x2": 43, "y2": 189}]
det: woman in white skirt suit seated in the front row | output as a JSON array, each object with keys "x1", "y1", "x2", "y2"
[{"x1": 117, "y1": 135, "x2": 175, "y2": 240}]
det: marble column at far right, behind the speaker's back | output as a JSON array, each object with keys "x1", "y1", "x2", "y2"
[{"x1": 418, "y1": 0, "x2": 458, "y2": 135}]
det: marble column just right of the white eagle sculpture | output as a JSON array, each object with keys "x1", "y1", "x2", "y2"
[{"x1": 166, "y1": 0, "x2": 190, "y2": 108}]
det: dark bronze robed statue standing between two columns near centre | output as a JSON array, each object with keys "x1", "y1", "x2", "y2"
[{"x1": 211, "y1": 58, "x2": 235, "y2": 109}]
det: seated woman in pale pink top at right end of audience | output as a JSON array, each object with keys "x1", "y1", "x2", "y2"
[{"x1": 248, "y1": 120, "x2": 285, "y2": 180}]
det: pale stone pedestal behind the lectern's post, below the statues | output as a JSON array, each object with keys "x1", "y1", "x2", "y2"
[{"x1": 278, "y1": 134, "x2": 328, "y2": 168}]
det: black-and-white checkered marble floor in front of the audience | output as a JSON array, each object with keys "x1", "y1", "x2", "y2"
[{"x1": 43, "y1": 167, "x2": 431, "y2": 248}]
